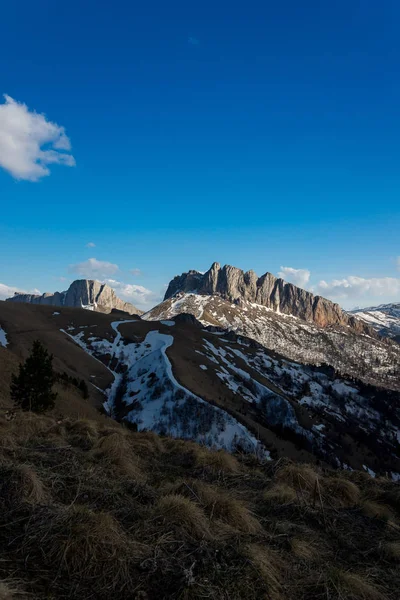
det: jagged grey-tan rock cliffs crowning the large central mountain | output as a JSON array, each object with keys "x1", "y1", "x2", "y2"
[{"x1": 164, "y1": 263, "x2": 372, "y2": 333}]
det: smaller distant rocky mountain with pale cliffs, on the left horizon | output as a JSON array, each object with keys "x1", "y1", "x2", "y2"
[{"x1": 7, "y1": 279, "x2": 143, "y2": 315}]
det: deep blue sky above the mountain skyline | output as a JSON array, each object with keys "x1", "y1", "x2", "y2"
[{"x1": 0, "y1": 0, "x2": 400, "y2": 308}]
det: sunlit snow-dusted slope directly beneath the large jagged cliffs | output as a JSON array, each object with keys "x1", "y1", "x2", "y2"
[{"x1": 142, "y1": 292, "x2": 400, "y2": 390}]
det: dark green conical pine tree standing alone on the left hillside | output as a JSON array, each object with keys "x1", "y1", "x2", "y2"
[{"x1": 11, "y1": 340, "x2": 57, "y2": 412}]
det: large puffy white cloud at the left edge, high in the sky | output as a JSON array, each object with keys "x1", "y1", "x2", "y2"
[{"x1": 0, "y1": 95, "x2": 75, "y2": 181}]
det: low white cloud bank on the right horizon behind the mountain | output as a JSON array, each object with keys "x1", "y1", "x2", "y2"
[{"x1": 314, "y1": 275, "x2": 400, "y2": 302}]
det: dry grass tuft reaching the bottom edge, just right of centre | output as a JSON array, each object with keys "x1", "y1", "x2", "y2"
[{"x1": 244, "y1": 544, "x2": 284, "y2": 600}]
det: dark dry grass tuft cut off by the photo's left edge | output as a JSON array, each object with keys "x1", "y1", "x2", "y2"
[{"x1": 0, "y1": 463, "x2": 46, "y2": 508}]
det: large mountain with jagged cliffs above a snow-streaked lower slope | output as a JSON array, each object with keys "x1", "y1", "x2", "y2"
[{"x1": 142, "y1": 263, "x2": 400, "y2": 389}]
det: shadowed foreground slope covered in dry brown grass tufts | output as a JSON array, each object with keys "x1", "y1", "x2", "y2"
[{"x1": 0, "y1": 414, "x2": 400, "y2": 600}]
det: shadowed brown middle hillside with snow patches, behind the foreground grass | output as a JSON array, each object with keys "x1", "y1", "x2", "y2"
[{"x1": 0, "y1": 303, "x2": 400, "y2": 479}]
